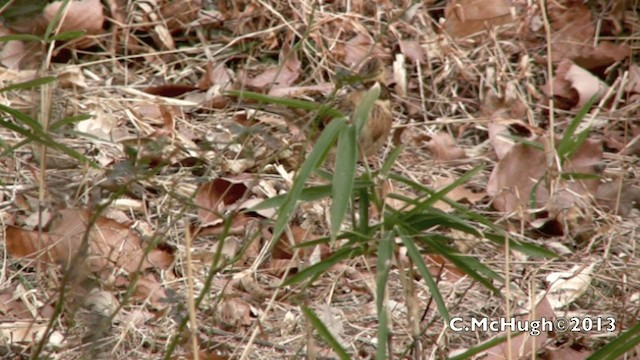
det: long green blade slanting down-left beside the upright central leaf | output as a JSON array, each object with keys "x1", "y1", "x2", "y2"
[{"x1": 271, "y1": 118, "x2": 346, "y2": 246}]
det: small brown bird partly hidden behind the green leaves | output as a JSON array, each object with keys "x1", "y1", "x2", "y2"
[{"x1": 238, "y1": 58, "x2": 393, "y2": 159}]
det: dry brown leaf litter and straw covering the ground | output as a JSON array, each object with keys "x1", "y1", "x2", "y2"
[{"x1": 0, "y1": 0, "x2": 640, "y2": 358}]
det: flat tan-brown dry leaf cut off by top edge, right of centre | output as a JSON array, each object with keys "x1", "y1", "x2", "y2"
[{"x1": 444, "y1": 0, "x2": 513, "y2": 37}]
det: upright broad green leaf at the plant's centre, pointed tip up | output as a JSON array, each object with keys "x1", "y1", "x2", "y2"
[{"x1": 329, "y1": 124, "x2": 358, "y2": 239}]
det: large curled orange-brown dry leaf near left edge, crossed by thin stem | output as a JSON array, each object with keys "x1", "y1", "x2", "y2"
[{"x1": 6, "y1": 209, "x2": 173, "y2": 272}]
